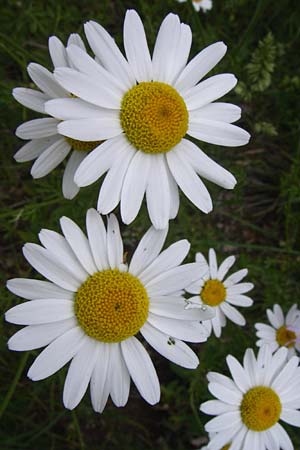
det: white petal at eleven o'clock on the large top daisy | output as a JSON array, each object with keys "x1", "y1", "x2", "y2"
[{"x1": 84, "y1": 21, "x2": 135, "y2": 89}]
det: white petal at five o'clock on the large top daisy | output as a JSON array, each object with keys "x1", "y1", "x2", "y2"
[{"x1": 167, "y1": 143, "x2": 212, "y2": 213}]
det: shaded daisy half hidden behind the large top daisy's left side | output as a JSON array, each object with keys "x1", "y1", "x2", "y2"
[{"x1": 13, "y1": 34, "x2": 100, "y2": 199}]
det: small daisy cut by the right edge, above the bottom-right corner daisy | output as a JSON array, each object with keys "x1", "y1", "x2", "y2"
[{"x1": 255, "y1": 305, "x2": 300, "y2": 357}]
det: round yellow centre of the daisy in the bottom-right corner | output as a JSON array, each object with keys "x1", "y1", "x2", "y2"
[{"x1": 240, "y1": 386, "x2": 281, "y2": 431}]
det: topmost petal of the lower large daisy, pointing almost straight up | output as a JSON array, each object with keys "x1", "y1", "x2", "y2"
[{"x1": 86, "y1": 209, "x2": 109, "y2": 270}]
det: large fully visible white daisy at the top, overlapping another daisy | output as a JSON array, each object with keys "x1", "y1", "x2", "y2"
[{"x1": 46, "y1": 10, "x2": 249, "y2": 229}]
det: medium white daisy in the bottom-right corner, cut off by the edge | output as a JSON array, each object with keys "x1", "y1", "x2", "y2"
[{"x1": 200, "y1": 346, "x2": 300, "y2": 450}]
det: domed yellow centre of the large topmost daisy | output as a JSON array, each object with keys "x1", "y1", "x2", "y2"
[{"x1": 120, "y1": 81, "x2": 188, "y2": 153}]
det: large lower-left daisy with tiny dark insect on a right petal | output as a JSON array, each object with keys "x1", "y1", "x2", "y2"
[{"x1": 5, "y1": 209, "x2": 212, "y2": 412}]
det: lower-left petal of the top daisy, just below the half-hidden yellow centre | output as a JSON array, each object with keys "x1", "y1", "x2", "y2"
[{"x1": 74, "y1": 136, "x2": 121, "y2": 187}]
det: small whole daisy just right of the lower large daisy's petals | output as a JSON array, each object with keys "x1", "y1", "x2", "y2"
[{"x1": 186, "y1": 248, "x2": 254, "y2": 337}]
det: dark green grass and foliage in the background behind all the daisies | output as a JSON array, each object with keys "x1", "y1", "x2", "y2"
[{"x1": 0, "y1": 0, "x2": 300, "y2": 450}]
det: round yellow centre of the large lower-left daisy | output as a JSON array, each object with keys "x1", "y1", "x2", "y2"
[{"x1": 75, "y1": 269, "x2": 149, "y2": 342}]
